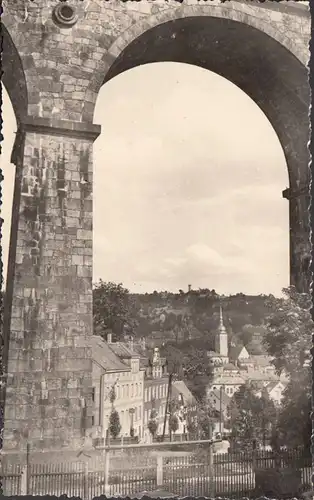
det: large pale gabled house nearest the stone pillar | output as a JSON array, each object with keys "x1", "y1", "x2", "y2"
[{"x1": 91, "y1": 334, "x2": 144, "y2": 440}]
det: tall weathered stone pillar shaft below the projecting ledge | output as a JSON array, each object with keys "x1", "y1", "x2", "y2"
[{"x1": 4, "y1": 124, "x2": 96, "y2": 451}]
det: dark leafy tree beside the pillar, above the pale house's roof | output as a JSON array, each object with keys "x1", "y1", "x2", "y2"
[{"x1": 93, "y1": 280, "x2": 137, "y2": 337}]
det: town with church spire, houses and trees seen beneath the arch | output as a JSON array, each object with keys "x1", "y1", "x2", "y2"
[{"x1": 92, "y1": 281, "x2": 311, "y2": 453}]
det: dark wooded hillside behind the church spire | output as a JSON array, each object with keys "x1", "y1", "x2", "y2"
[{"x1": 130, "y1": 290, "x2": 268, "y2": 348}]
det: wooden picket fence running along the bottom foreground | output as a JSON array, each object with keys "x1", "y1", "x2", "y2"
[{"x1": 1, "y1": 448, "x2": 312, "y2": 499}]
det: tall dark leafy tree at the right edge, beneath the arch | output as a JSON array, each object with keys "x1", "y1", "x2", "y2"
[{"x1": 264, "y1": 287, "x2": 313, "y2": 449}]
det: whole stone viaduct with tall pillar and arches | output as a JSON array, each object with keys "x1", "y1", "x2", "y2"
[{"x1": 3, "y1": 0, "x2": 310, "y2": 453}]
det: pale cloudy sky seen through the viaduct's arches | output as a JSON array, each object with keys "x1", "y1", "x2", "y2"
[{"x1": 0, "y1": 63, "x2": 289, "y2": 295}]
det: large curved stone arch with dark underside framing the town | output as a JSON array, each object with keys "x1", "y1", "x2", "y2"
[{"x1": 82, "y1": 3, "x2": 310, "y2": 289}]
